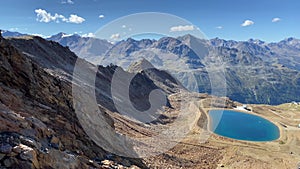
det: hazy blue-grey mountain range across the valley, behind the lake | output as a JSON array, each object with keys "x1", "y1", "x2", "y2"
[{"x1": 4, "y1": 30, "x2": 300, "y2": 104}]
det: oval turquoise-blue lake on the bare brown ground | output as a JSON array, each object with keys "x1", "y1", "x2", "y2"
[{"x1": 209, "y1": 110, "x2": 280, "y2": 141}]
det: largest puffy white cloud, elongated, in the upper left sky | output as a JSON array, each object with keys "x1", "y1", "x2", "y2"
[{"x1": 35, "y1": 9, "x2": 85, "y2": 24}]
